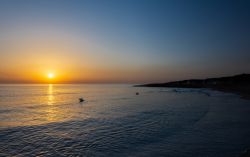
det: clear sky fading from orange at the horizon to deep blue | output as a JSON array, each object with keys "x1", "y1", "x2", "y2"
[{"x1": 0, "y1": 0, "x2": 250, "y2": 83}]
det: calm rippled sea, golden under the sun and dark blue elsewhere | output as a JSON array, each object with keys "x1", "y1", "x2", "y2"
[{"x1": 0, "y1": 84, "x2": 250, "y2": 157}]
